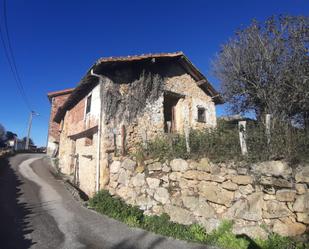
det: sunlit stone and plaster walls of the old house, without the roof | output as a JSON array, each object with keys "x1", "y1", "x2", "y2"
[{"x1": 51, "y1": 53, "x2": 218, "y2": 196}]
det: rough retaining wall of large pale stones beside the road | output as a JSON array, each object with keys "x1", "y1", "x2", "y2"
[{"x1": 107, "y1": 158, "x2": 309, "y2": 238}]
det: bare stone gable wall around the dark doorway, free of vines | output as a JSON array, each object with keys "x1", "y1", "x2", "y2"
[{"x1": 105, "y1": 69, "x2": 217, "y2": 154}]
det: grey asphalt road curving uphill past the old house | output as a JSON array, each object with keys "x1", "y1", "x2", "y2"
[{"x1": 0, "y1": 154, "x2": 214, "y2": 249}]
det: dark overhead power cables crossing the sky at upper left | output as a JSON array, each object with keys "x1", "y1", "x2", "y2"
[{"x1": 0, "y1": 0, "x2": 32, "y2": 111}]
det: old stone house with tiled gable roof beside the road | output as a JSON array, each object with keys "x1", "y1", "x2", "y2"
[{"x1": 47, "y1": 52, "x2": 223, "y2": 196}]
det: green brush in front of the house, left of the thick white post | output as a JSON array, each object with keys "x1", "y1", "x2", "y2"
[{"x1": 139, "y1": 122, "x2": 240, "y2": 161}]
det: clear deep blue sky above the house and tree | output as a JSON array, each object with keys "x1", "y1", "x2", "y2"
[{"x1": 0, "y1": 0, "x2": 309, "y2": 145}]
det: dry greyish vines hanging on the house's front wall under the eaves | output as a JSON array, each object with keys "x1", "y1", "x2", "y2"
[{"x1": 102, "y1": 68, "x2": 163, "y2": 123}]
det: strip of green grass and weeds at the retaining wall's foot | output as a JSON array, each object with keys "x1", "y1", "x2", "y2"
[{"x1": 89, "y1": 190, "x2": 309, "y2": 249}]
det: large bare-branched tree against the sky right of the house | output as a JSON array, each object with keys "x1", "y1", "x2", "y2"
[{"x1": 213, "y1": 16, "x2": 309, "y2": 125}]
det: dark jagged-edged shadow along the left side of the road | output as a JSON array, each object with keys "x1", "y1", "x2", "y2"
[{"x1": 0, "y1": 158, "x2": 35, "y2": 249}]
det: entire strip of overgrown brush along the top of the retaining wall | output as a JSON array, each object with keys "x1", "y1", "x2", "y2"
[{"x1": 136, "y1": 120, "x2": 309, "y2": 164}]
